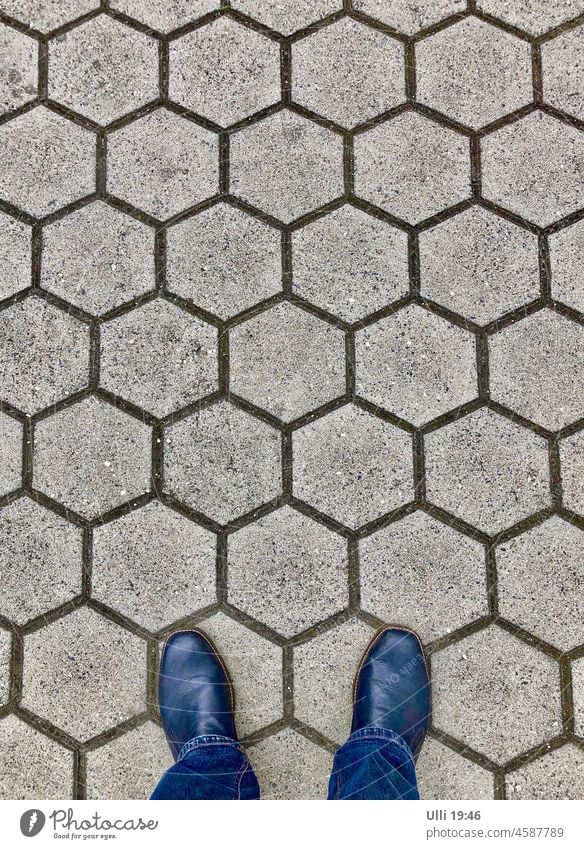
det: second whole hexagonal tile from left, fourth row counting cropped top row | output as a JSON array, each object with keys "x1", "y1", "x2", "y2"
[{"x1": 166, "y1": 203, "x2": 282, "y2": 319}]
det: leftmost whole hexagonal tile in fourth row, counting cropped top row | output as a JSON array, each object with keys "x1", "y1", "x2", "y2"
[{"x1": 41, "y1": 201, "x2": 155, "y2": 315}]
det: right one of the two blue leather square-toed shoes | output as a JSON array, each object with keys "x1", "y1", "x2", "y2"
[{"x1": 351, "y1": 626, "x2": 431, "y2": 759}]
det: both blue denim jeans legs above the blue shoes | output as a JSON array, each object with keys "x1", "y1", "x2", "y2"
[{"x1": 150, "y1": 728, "x2": 420, "y2": 799}]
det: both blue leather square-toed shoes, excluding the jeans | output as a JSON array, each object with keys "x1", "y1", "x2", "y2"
[{"x1": 158, "y1": 627, "x2": 430, "y2": 759}]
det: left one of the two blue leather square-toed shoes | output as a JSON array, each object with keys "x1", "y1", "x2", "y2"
[{"x1": 158, "y1": 629, "x2": 237, "y2": 758}]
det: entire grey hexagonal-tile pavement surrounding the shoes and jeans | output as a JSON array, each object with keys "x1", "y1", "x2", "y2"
[{"x1": 0, "y1": 0, "x2": 584, "y2": 799}]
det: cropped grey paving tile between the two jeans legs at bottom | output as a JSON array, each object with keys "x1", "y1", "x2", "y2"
[{"x1": 249, "y1": 728, "x2": 333, "y2": 799}]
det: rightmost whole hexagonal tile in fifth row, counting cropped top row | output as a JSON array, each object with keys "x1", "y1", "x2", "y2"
[{"x1": 355, "y1": 304, "x2": 478, "y2": 425}]
